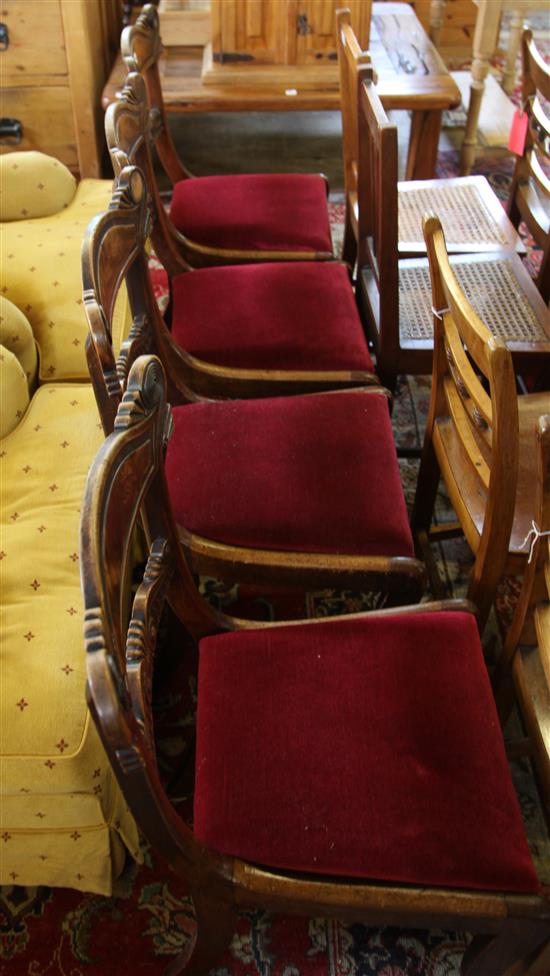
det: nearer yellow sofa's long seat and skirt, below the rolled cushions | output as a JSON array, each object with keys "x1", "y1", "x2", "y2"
[{"x1": 0, "y1": 383, "x2": 139, "y2": 894}]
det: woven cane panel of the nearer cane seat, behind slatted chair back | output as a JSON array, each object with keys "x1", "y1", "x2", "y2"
[{"x1": 399, "y1": 258, "x2": 547, "y2": 342}]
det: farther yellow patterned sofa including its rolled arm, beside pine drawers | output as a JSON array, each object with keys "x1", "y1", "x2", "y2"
[{"x1": 0, "y1": 152, "x2": 128, "y2": 382}]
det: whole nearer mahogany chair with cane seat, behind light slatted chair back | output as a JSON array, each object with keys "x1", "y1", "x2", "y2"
[{"x1": 357, "y1": 68, "x2": 550, "y2": 389}]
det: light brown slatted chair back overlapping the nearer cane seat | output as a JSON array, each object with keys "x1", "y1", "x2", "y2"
[{"x1": 424, "y1": 214, "x2": 519, "y2": 562}]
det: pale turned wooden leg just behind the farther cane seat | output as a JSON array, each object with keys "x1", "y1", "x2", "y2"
[{"x1": 460, "y1": 0, "x2": 501, "y2": 176}]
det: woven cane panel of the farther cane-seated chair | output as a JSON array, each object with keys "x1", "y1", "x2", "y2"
[{"x1": 399, "y1": 184, "x2": 507, "y2": 244}]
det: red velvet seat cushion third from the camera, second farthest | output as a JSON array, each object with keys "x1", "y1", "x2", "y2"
[{"x1": 172, "y1": 261, "x2": 374, "y2": 372}]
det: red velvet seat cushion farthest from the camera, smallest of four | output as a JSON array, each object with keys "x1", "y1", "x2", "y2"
[{"x1": 170, "y1": 173, "x2": 332, "y2": 253}]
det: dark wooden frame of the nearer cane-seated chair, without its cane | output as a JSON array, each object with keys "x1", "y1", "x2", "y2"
[{"x1": 357, "y1": 74, "x2": 550, "y2": 389}]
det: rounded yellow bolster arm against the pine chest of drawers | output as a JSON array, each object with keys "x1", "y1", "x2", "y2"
[{"x1": 0, "y1": 150, "x2": 76, "y2": 221}]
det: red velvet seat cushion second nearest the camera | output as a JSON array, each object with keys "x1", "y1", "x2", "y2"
[{"x1": 166, "y1": 393, "x2": 413, "y2": 556}]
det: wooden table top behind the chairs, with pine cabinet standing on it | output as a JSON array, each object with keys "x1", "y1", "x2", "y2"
[{"x1": 102, "y1": 3, "x2": 460, "y2": 112}]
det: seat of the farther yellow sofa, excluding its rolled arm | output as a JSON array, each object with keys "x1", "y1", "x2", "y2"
[{"x1": 0, "y1": 180, "x2": 130, "y2": 382}]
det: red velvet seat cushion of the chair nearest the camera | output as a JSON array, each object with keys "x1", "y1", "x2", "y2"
[{"x1": 194, "y1": 613, "x2": 538, "y2": 892}]
